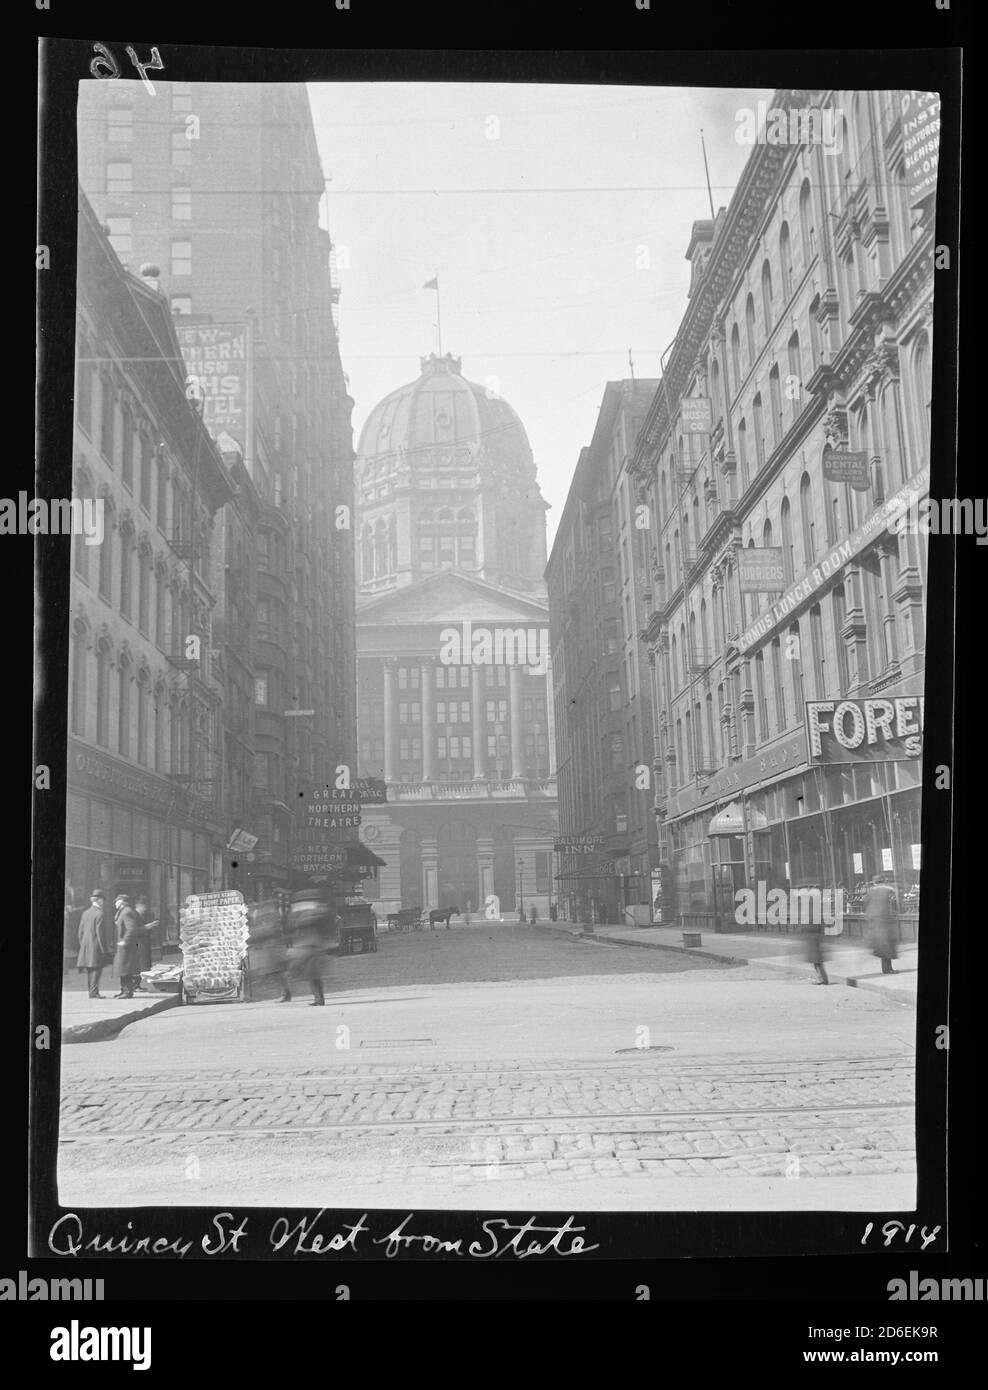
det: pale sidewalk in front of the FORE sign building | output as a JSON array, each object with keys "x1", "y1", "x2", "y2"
[{"x1": 539, "y1": 922, "x2": 919, "y2": 1008}]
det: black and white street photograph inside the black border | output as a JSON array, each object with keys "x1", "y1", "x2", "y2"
[{"x1": 50, "y1": 70, "x2": 944, "y2": 1212}]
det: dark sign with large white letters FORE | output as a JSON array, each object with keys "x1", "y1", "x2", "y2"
[{"x1": 806, "y1": 695, "x2": 923, "y2": 766}]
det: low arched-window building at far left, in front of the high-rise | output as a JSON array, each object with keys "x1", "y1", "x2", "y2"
[{"x1": 65, "y1": 193, "x2": 232, "y2": 948}]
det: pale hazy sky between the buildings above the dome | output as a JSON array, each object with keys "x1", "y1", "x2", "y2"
[{"x1": 308, "y1": 83, "x2": 771, "y2": 545}]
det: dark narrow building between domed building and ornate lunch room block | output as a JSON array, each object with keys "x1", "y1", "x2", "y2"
[{"x1": 546, "y1": 381, "x2": 659, "y2": 924}]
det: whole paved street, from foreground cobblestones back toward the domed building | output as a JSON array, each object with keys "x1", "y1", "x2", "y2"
[{"x1": 60, "y1": 923, "x2": 914, "y2": 1209}]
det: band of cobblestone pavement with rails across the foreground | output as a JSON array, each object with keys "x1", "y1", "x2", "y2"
[{"x1": 60, "y1": 1051, "x2": 914, "y2": 1184}]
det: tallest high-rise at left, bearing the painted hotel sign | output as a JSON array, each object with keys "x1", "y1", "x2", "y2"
[{"x1": 79, "y1": 79, "x2": 356, "y2": 898}]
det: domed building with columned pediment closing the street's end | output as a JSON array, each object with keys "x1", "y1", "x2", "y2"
[{"x1": 356, "y1": 354, "x2": 557, "y2": 919}]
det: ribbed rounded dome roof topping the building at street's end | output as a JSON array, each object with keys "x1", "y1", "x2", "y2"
[{"x1": 357, "y1": 353, "x2": 535, "y2": 480}]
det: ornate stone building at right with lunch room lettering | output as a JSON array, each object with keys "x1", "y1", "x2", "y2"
[{"x1": 627, "y1": 92, "x2": 937, "y2": 931}]
